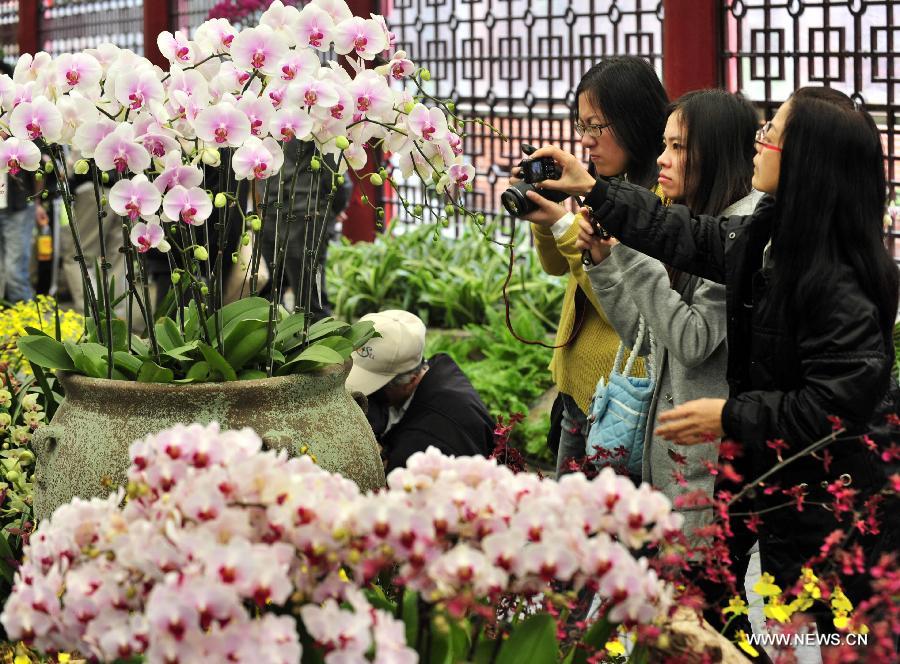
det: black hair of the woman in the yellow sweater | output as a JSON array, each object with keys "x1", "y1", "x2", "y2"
[{"x1": 573, "y1": 55, "x2": 669, "y2": 188}]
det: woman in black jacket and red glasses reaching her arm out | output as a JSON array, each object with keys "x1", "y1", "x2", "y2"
[{"x1": 533, "y1": 88, "x2": 898, "y2": 631}]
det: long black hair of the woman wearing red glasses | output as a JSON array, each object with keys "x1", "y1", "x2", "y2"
[{"x1": 772, "y1": 87, "x2": 900, "y2": 340}]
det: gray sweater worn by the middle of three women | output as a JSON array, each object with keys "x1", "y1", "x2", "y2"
[{"x1": 586, "y1": 191, "x2": 762, "y2": 544}]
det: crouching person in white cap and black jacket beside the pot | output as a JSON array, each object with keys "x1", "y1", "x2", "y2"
[{"x1": 347, "y1": 310, "x2": 494, "y2": 472}]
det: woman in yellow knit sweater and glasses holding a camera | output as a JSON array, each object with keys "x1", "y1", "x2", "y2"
[{"x1": 514, "y1": 56, "x2": 668, "y2": 475}]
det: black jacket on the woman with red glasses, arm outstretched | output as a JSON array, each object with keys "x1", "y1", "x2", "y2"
[{"x1": 585, "y1": 179, "x2": 896, "y2": 596}]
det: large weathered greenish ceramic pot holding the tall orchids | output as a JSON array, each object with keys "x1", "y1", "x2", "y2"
[{"x1": 32, "y1": 361, "x2": 385, "y2": 518}]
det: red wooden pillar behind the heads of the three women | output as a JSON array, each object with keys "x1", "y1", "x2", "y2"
[{"x1": 663, "y1": 0, "x2": 722, "y2": 99}]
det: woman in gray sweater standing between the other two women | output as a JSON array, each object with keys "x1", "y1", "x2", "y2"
[{"x1": 576, "y1": 90, "x2": 761, "y2": 544}]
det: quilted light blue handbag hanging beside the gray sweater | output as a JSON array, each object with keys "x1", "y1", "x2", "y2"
[{"x1": 585, "y1": 316, "x2": 655, "y2": 477}]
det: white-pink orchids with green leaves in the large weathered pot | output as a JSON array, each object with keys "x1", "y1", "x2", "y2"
[{"x1": 0, "y1": 0, "x2": 474, "y2": 516}]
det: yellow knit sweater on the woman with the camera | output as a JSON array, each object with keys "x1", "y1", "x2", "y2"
[{"x1": 531, "y1": 220, "x2": 644, "y2": 413}]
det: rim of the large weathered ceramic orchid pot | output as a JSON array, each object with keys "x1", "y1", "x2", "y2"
[{"x1": 57, "y1": 359, "x2": 353, "y2": 393}]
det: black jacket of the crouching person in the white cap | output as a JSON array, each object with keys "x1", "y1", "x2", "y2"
[{"x1": 369, "y1": 353, "x2": 494, "y2": 472}]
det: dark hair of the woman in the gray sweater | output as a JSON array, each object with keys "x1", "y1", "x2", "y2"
[{"x1": 670, "y1": 90, "x2": 759, "y2": 215}]
